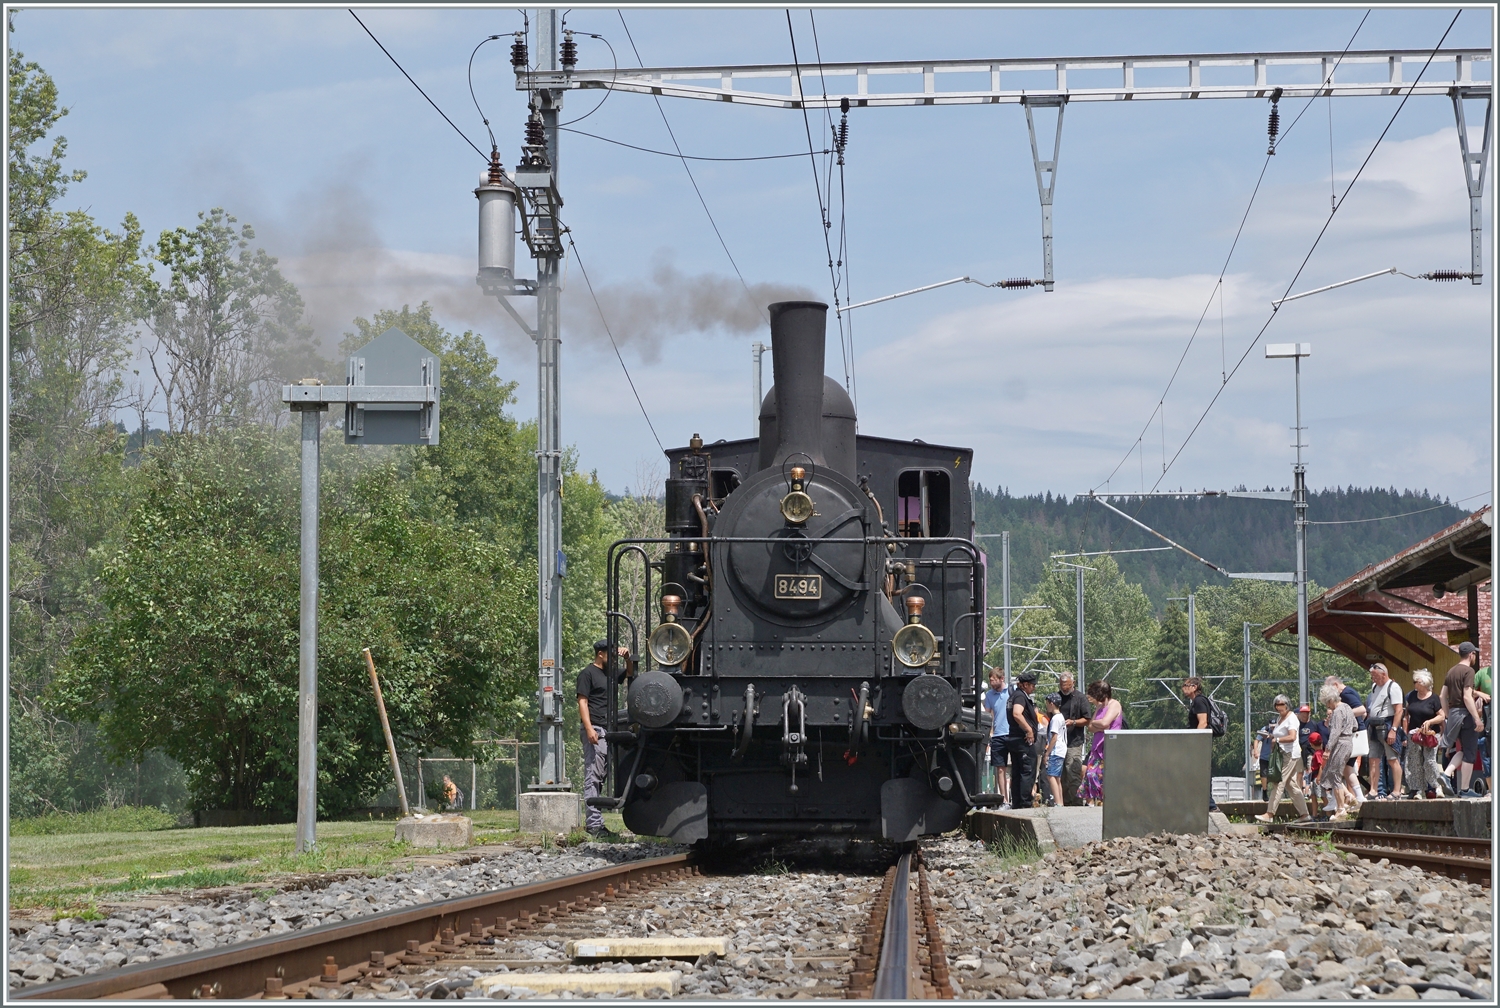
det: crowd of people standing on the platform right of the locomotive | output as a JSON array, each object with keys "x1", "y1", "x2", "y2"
[{"x1": 980, "y1": 641, "x2": 1493, "y2": 822}]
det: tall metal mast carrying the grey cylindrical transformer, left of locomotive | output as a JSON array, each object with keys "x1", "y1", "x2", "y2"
[{"x1": 534, "y1": 8, "x2": 570, "y2": 791}]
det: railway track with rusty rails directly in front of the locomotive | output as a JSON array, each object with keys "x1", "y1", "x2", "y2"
[{"x1": 9, "y1": 849, "x2": 953, "y2": 1001}]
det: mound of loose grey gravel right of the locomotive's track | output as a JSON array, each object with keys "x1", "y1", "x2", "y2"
[{"x1": 924, "y1": 834, "x2": 1493, "y2": 1001}]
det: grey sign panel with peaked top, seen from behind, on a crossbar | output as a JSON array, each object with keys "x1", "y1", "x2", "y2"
[{"x1": 344, "y1": 329, "x2": 440, "y2": 446}]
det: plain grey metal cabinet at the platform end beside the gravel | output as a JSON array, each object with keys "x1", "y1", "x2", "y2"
[{"x1": 1103, "y1": 728, "x2": 1214, "y2": 840}]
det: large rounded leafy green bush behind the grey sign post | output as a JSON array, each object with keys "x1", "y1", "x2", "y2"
[{"x1": 57, "y1": 428, "x2": 536, "y2": 815}]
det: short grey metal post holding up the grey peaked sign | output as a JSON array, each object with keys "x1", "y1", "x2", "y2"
[{"x1": 297, "y1": 405, "x2": 327, "y2": 854}]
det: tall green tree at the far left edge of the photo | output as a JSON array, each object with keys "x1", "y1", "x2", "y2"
[{"x1": 6, "y1": 35, "x2": 161, "y2": 815}]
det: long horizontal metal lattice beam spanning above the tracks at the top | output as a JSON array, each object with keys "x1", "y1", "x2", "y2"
[{"x1": 516, "y1": 48, "x2": 1491, "y2": 110}]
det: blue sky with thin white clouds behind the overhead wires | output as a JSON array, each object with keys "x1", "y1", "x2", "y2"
[{"x1": 11, "y1": 6, "x2": 1496, "y2": 504}]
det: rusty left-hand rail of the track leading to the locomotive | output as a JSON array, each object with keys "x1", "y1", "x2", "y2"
[{"x1": 8, "y1": 854, "x2": 690, "y2": 1001}]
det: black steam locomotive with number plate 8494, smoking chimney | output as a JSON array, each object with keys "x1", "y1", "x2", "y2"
[{"x1": 591, "y1": 302, "x2": 990, "y2": 843}]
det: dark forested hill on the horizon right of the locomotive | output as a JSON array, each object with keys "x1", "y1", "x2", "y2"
[{"x1": 974, "y1": 485, "x2": 1472, "y2": 612}]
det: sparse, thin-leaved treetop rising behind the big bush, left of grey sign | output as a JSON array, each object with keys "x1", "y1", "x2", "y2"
[{"x1": 146, "y1": 207, "x2": 327, "y2": 434}]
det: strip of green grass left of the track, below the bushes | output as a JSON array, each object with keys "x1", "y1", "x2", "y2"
[{"x1": 9, "y1": 810, "x2": 623, "y2": 915}]
